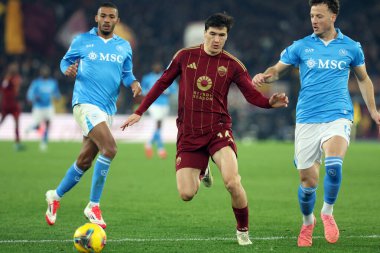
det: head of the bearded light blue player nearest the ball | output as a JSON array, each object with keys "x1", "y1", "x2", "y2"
[{"x1": 95, "y1": 7, "x2": 119, "y2": 38}]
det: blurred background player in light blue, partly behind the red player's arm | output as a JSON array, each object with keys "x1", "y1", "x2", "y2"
[{"x1": 141, "y1": 62, "x2": 177, "y2": 159}]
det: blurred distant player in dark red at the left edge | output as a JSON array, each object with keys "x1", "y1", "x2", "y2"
[{"x1": 0, "y1": 63, "x2": 24, "y2": 151}]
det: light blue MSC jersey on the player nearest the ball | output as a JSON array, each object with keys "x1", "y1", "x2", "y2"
[{"x1": 61, "y1": 27, "x2": 136, "y2": 115}]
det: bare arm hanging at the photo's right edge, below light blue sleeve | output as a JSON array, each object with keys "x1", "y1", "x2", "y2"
[{"x1": 354, "y1": 65, "x2": 380, "y2": 127}]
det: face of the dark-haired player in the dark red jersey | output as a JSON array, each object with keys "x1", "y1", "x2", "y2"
[{"x1": 204, "y1": 27, "x2": 227, "y2": 55}]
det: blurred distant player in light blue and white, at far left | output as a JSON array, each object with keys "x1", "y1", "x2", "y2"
[{"x1": 26, "y1": 66, "x2": 61, "y2": 151}]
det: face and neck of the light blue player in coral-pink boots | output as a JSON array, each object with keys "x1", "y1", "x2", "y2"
[{"x1": 310, "y1": 4, "x2": 336, "y2": 38}]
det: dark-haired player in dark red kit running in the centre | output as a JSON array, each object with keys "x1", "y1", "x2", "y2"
[{"x1": 121, "y1": 13, "x2": 288, "y2": 245}]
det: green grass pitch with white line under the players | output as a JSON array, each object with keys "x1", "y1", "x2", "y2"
[{"x1": 0, "y1": 142, "x2": 380, "y2": 253}]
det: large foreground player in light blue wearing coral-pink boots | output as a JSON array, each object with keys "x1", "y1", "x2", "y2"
[{"x1": 252, "y1": 0, "x2": 380, "y2": 247}]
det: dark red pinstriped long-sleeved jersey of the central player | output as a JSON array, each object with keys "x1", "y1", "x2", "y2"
[{"x1": 136, "y1": 44, "x2": 271, "y2": 134}]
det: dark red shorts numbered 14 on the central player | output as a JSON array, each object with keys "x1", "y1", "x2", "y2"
[{"x1": 176, "y1": 129, "x2": 237, "y2": 172}]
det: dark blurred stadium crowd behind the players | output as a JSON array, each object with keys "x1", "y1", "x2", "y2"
[{"x1": 0, "y1": 0, "x2": 380, "y2": 140}]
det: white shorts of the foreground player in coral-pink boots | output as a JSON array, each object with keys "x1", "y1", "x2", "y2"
[{"x1": 294, "y1": 119, "x2": 352, "y2": 169}]
